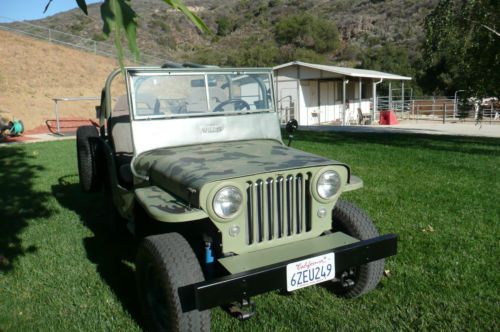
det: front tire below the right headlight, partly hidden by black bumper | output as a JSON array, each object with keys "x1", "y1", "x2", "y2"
[{"x1": 332, "y1": 200, "x2": 385, "y2": 298}]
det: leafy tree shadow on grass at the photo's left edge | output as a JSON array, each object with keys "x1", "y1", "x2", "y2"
[{"x1": 0, "y1": 146, "x2": 50, "y2": 272}]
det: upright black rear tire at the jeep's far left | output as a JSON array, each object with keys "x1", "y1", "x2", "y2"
[{"x1": 76, "y1": 126, "x2": 103, "y2": 192}]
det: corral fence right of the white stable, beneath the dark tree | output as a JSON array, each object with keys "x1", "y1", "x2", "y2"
[{"x1": 377, "y1": 96, "x2": 500, "y2": 124}]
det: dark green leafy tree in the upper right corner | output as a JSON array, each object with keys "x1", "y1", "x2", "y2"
[{"x1": 421, "y1": 0, "x2": 500, "y2": 96}]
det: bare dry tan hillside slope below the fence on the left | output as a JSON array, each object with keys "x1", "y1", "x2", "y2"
[{"x1": 0, "y1": 30, "x2": 117, "y2": 129}]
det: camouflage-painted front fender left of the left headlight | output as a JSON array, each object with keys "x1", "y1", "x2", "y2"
[{"x1": 135, "y1": 186, "x2": 208, "y2": 222}]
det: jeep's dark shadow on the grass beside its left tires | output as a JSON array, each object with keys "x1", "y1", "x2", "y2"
[{"x1": 52, "y1": 175, "x2": 144, "y2": 327}]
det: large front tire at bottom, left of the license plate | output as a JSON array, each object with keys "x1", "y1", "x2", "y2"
[{"x1": 136, "y1": 233, "x2": 210, "y2": 331}]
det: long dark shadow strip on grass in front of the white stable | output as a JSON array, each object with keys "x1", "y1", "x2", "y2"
[{"x1": 292, "y1": 131, "x2": 500, "y2": 156}]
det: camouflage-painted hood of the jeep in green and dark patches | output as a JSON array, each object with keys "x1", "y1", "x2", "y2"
[{"x1": 134, "y1": 140, "x2": 344, "y2": 206}]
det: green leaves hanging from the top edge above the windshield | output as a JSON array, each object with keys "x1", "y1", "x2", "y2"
[{"x1": 44, "y1": 0, "x2": 210, "y2": 67}]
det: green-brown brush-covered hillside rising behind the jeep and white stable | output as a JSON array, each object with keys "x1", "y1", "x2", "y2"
[{"x1": 25, "y1": 0, "x2": 437, "y2": 67}]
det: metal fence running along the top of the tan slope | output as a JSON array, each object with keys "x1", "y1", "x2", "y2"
[{"x1": 0, "y1": 16, "x2": 165, "y2": 65}]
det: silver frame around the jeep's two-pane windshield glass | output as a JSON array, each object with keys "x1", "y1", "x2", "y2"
[{"x1": 125, "y1": 67, "x2": 276, "y2": 121}]
